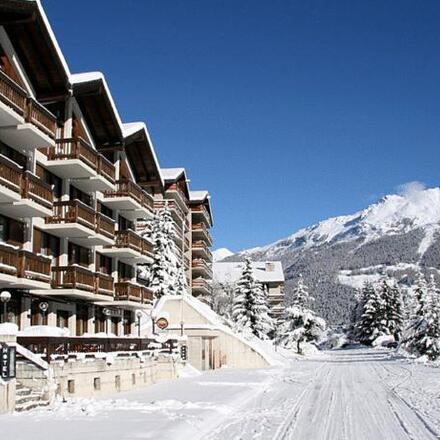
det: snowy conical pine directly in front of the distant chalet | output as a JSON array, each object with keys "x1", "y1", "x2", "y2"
[{"x1": 231, "y1": 259, "x2": 274, "y2": 339}]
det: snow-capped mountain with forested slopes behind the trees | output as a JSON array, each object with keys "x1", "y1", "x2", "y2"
[{"x1": 226, "y1": 183, "x2": 440, "y2": 322}]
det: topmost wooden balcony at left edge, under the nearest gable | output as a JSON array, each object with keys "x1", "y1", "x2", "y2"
[{"x1": 0, "y1": 70, "x2": 57, "y2": 150}]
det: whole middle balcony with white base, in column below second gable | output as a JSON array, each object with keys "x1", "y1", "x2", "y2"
[{"x1": 44, "y1": 200, "x2": 115, "y2": 247}]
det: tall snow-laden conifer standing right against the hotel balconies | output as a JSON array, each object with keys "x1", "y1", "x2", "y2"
[{"x1": 137, "y1": 206, "x2": 186, "y2": 298}]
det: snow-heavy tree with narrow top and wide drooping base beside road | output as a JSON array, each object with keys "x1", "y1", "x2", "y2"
[{"x1": 276, "y1": 276, "x2": 326, "y2": 354}]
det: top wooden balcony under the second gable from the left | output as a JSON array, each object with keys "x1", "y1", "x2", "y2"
[{"x1": 40, "y1": 137, "x2": 115, "y2": 192}]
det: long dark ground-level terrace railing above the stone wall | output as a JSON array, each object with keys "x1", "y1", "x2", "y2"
[{"x1": 17, "y1": 336, "x2": 177, "y2": 362}]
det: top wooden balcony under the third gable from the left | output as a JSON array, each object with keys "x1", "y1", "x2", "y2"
[{"x1": 102, "y1": 180, "x2": 153, "y2": 220}]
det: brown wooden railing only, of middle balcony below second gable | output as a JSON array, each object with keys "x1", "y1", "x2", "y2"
[{"x1": 46, "y1": 200, "x2": 115, "y2": 238}]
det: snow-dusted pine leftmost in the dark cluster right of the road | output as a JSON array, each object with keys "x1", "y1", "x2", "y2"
[{"x1": 355, "y1": 282, "x2": 389, "y2": 345}]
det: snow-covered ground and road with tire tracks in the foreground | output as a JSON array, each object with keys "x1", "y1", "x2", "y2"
[{"x1": 0, "y1": 349, "x2": 440, "y2": 440}]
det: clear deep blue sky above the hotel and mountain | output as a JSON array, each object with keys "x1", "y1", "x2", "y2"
[{"x1": 43, "y1": 0, "x2": 440, "y2": 250}]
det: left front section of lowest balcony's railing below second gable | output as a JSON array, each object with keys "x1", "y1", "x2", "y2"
[{"x1": 52, "y1": 265, "x2": 95, "y2": 292}]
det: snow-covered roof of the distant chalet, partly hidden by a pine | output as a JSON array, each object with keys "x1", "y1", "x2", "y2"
[{"x1": 212, "y1": 261, "x2": 284, "y2": 283}]
